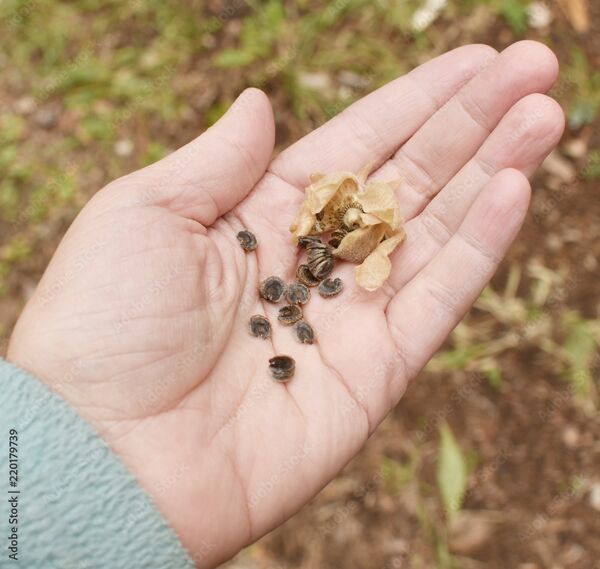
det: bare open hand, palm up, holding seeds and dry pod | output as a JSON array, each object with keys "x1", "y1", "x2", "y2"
[{"x1": 9, "y1": 42, "x2": 563, "y2": 567}]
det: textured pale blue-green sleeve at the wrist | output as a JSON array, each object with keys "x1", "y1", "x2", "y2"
[{"x1": 0, "y1": 358, "x2": 194, "y2": 569}]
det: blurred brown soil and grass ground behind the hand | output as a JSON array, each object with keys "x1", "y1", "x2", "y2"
[{"x1": 0, "y1": 0, "x2": 600, "y2": 569}]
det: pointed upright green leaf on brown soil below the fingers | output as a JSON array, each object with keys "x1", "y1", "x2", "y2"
[{"x1": 437, "y1": 423, "x2": 468, "y2": 518}]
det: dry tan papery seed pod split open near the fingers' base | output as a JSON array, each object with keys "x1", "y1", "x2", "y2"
[{"x1": 290, "y1": 165, "x2": 406, "y2": 291}]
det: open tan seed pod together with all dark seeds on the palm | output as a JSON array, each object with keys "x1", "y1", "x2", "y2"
[{"x1": 237, "y1": 166, "x2": 405, "y2": 382}]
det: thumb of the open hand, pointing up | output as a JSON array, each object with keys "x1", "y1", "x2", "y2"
[{"x1": 135, "y1": 88, "x2": 275, "y2": 226}]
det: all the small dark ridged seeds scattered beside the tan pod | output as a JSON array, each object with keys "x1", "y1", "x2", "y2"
[{"x1": 237, "y1": 229, "x2": 343, "y2": 382}]
